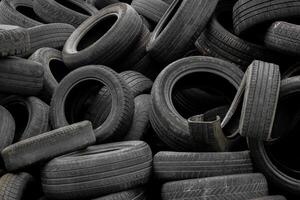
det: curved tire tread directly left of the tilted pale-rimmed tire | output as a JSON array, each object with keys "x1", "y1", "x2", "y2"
[{"x1": 27, "y1": 23, "x2": 75, "y2": 55}]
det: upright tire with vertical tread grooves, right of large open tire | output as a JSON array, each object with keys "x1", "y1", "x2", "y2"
[{"x1": 238, "y1": 60, "x2": 281, "y2": 140}]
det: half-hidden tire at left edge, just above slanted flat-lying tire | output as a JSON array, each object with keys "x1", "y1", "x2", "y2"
[{"x1": 0, "y1": 95, "x2": 49, "y2": 143}]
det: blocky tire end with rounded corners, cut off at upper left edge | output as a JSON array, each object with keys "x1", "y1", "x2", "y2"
[{"x1": 0, "y1": 26, "x2": 30, "y2": 57}]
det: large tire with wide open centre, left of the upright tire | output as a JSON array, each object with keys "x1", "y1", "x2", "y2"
[{"x1": 150, "y1": 56, "x2": 243, "y2": 151}]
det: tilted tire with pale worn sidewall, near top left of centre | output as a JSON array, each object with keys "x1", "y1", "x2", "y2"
[{"x1": 63, "y1": 3, "x2": 143, "y2": 69}]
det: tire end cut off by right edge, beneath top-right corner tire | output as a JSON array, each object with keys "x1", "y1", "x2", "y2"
[{"x1": 265, "y1": 22, "x2": 300, "y2": 56}]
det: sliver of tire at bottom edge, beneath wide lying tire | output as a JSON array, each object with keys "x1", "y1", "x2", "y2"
[{"x1": 92, "y1": 189, "x2": 146, "y2": 200}]
